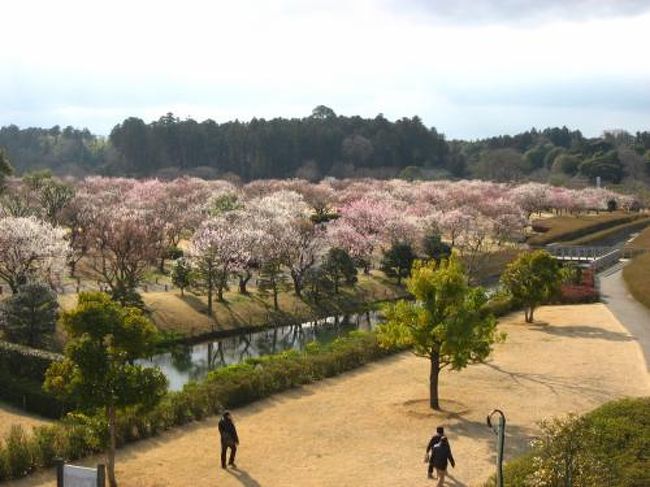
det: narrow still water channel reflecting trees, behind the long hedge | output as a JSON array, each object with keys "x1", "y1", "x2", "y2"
[{"x1": 139, "y1": 311, "x2": 379, "y2": 391}]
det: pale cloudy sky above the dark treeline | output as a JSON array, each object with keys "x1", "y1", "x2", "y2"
[{"x1": 0, "y1": 0, "x2": 650, "y2": 139}]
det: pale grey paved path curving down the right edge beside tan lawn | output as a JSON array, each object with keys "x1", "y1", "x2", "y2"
[{"x1": 598, "y1": 262, "x2": 650, "y2": 373}]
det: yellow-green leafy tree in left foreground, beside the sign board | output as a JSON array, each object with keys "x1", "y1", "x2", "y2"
[{"x1": 44, "y1": 293, "x2": 167, "y2": 487}]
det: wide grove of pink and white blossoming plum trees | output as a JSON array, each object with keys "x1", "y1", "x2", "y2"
[{"x1": 0, "y1": 176, "x2": 638, "y2": 301}]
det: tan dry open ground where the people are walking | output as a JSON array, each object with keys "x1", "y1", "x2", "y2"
[{"x1": 8, "y1": 304, "x2": 650, "y2": 487}]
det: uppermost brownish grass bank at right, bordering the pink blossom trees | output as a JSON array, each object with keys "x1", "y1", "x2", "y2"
[{"x1": 528, "y1": 211, "x2": 648, "y2": 246}]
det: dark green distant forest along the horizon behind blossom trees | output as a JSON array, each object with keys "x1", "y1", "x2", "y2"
[{"x1": 0, "y1": 105, "x2": 650, "y2": 184}]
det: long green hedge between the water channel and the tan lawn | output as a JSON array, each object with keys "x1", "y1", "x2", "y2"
[{"x1": 0, "y1": 332, "x2": 399, "y2": 481}]
